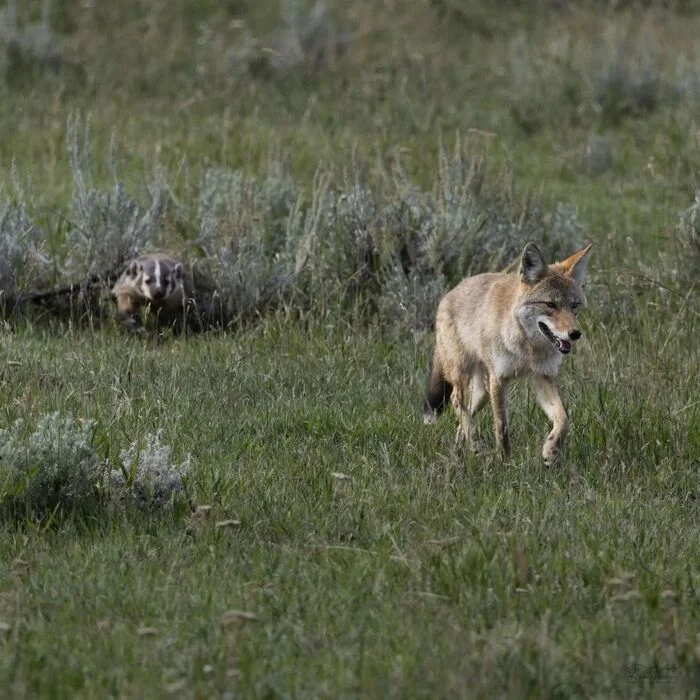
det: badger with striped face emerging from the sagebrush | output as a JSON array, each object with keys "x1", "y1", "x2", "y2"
[{"x1": 112, "y1": 253, "x2": 187, "y2": 332}]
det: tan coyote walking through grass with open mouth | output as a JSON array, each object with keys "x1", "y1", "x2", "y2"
[{"x1": 424, "y1": 243, "x2": 592, "y2": 464}]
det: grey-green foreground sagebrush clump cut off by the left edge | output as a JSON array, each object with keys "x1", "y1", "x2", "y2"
[{"x1": 0, "y1": 412, "x2": 101, "y2": 518}]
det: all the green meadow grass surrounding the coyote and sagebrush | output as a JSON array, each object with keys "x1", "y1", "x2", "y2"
[{"x1": 0, "y1": 0, "x2": 700, "y2": 698}]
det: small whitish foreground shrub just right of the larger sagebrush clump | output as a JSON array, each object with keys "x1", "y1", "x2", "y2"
[{"x1": 109, "y1": 431, "x2": 191, "y2": 512}]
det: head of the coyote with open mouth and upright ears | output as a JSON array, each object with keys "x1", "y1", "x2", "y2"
[{"x1": 515, "y1": 243, "x2": 592, "y2": 355}]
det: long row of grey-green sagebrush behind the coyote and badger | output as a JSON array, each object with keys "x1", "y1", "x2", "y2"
[{"x1": 0, "y1": 125, "x2": 580, "y2": 330}]
